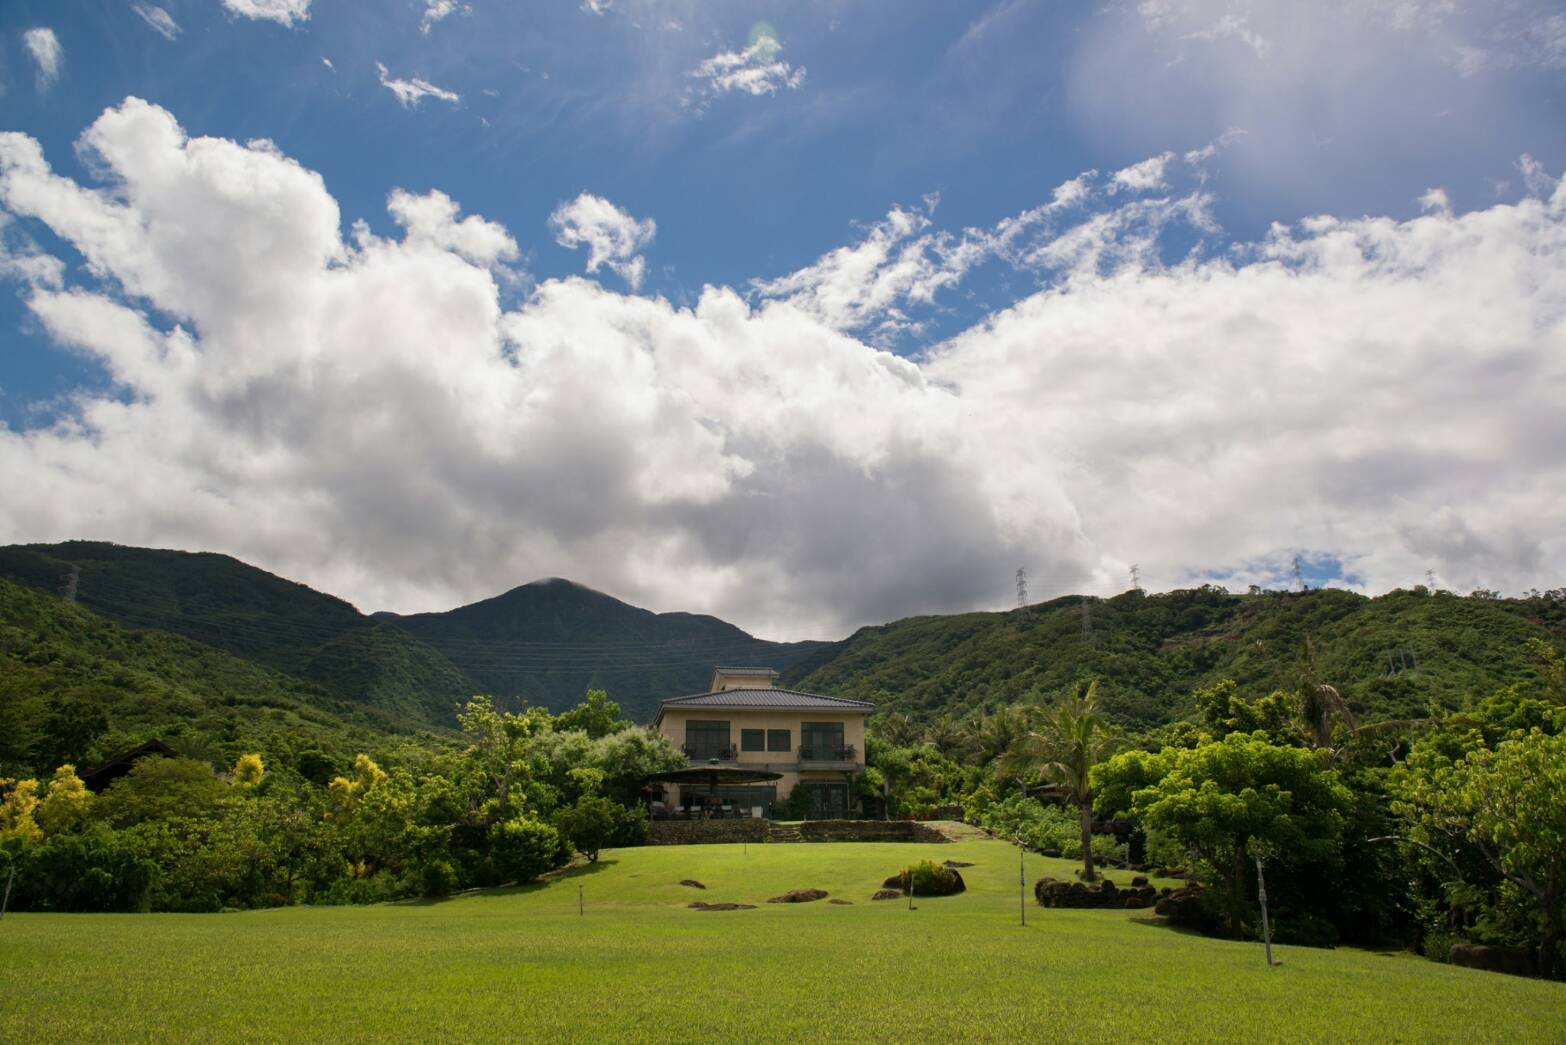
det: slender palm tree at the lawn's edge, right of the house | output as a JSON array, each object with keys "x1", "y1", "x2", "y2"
[{"x1": 1001, "y1": 682, "x2": 1120, "y2": 882}]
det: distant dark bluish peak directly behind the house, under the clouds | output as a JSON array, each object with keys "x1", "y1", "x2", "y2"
[{"x1": 376, "y1": 578, "x2": 824, "y2": 721}]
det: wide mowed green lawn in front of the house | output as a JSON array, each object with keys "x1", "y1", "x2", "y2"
[{"x1": 0, "y1": 840, "x2": 1566, "y2": 1042}]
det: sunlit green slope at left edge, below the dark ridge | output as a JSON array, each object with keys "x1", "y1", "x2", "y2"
[{"x1": 0, "y1": 578, "x2": 453, "y2": 782}]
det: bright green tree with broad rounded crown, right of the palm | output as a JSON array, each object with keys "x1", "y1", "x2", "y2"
[{"x1": 1093, "y1": 733, "x2": 1351, "y2": 934}]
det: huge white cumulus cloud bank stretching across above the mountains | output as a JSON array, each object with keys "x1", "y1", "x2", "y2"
[{"x1": 0, "y1": 99, "x2": 1566, "y2": 638}]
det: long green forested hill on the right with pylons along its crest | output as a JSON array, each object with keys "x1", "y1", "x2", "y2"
[{"x1": 783, "y1": 588, "x2": 1566, "y2": 727}]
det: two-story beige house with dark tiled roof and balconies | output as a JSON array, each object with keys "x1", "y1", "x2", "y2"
[{"x1": 653, "y1": 667, "x2": 875, "y2": 816}]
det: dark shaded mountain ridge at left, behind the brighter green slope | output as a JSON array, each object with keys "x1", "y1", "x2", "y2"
[{"x1": 0, "y1": 541, "x2": 478, "y2": 724}]
